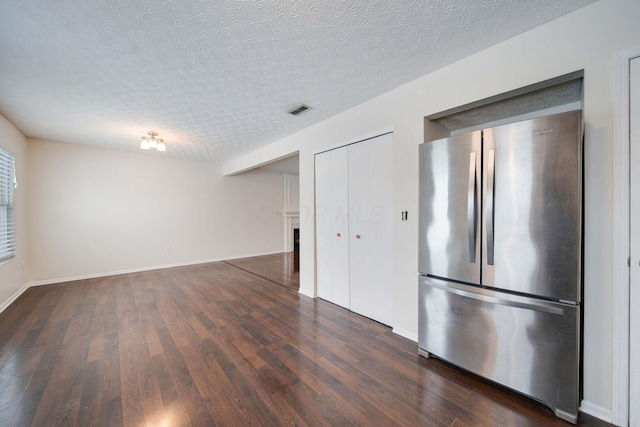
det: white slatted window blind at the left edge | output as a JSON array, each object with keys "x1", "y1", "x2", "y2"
[{"x1": 0, "y1": 148, "x2": 16, "y2": 262}]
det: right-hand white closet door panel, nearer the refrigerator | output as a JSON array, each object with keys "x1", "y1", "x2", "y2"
[{"x1": 348, "y1": 134, "x2": 393, "y2": 325}]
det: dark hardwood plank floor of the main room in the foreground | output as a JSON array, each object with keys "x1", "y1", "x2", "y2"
[{"x1": 0, "y1": 260, "x2": 604, "y2": 426}]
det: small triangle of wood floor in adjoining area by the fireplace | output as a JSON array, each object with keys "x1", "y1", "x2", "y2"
[{"x1": 225, "y1": 252, "x2": 300, "y2": 292}]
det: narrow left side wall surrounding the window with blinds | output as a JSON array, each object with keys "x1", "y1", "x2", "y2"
[{"x1": 0, "y1": 116, "x2": 27, "y2": 311}]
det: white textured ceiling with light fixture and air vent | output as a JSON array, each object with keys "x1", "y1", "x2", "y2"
[{"x1": 0, "y1": 0, "x2": 594, "y2": 163}]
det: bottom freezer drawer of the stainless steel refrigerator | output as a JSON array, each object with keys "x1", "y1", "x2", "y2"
[{"x1": 418, "y1": 276, "x2": 580, "y2": 423}]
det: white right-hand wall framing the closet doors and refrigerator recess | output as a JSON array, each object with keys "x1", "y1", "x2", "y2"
[{"x1": 223, "y1": 0, "x2": 640, "y2": 419}]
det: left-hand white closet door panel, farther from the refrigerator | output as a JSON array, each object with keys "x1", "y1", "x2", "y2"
[{"x1": 315, "y1": 149, "x2": 349, "y2": 308}]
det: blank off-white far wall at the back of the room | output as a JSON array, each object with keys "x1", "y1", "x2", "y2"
[{"x1": 28, "y1": 139, "x2": 284, "y2": 282}]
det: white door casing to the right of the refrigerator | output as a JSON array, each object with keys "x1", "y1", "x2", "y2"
[{"x1": 611, "y1": 46, "x2": 640, "y2": 426}]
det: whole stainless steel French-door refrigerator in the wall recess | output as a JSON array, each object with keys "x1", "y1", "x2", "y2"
[{"x1": 418, "y1": 111, "x2": 583, "y2": 423}]
